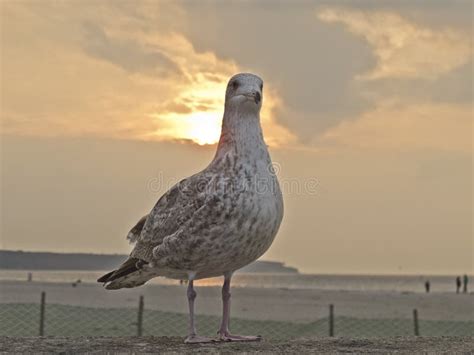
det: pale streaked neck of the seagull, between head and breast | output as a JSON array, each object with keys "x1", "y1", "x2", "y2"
[{"x1": 215, "y1": 111, "x2": 267, "y2": 159}]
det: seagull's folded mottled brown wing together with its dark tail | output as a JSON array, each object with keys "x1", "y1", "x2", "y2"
[{"x1": 98, "y1": 172, "x2": 217, "y2": 289}]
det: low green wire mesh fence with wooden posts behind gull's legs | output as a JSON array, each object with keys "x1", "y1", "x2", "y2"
[{"x1": 0, "y1": 292, "x2": 474, "y2": 339}]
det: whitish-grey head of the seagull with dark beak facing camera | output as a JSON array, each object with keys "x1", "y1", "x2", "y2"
[{"x1": 225, "y1": 73, "x2": 263, "y2": 113}]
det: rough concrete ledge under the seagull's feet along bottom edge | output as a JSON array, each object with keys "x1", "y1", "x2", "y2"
[{"x1": 0, "y1": 337, "x2": 474, "y2": 354}]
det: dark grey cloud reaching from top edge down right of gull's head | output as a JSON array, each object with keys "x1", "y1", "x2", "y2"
[{"x1": 180, "y1": 1, "x2": 374, "y2": 143}]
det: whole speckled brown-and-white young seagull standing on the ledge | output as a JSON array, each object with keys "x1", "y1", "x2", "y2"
[{"x1": 97, "y1": 73, "x2": 283, "y2": 343}]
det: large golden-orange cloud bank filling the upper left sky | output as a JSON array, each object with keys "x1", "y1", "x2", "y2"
[{"x1": 1, "y1": 1, "x2": 292, "y2": 144}]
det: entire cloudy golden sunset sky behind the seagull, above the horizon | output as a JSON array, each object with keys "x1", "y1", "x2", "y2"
[{"x1": 0, "y1": 0, "x2": 474, "y2": 274}]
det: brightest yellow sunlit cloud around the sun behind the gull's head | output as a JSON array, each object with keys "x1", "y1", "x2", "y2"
[{"x1": 137, "y1": 35, "x2": 296, "y2": 146}]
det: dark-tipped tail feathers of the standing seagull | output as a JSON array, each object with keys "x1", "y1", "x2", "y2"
[{"x1": 97, "y1": 258, "x2": 155, "y2": 290}]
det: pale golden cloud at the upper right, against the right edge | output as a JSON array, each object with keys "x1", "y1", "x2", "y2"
[{"x1": 312, "y1": 3, "x2": 472, "y2": 154}]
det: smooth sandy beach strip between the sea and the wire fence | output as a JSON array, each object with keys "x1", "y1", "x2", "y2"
[{"x1": 0, "y1": 281, "x2": 474, "y2": 323}]
